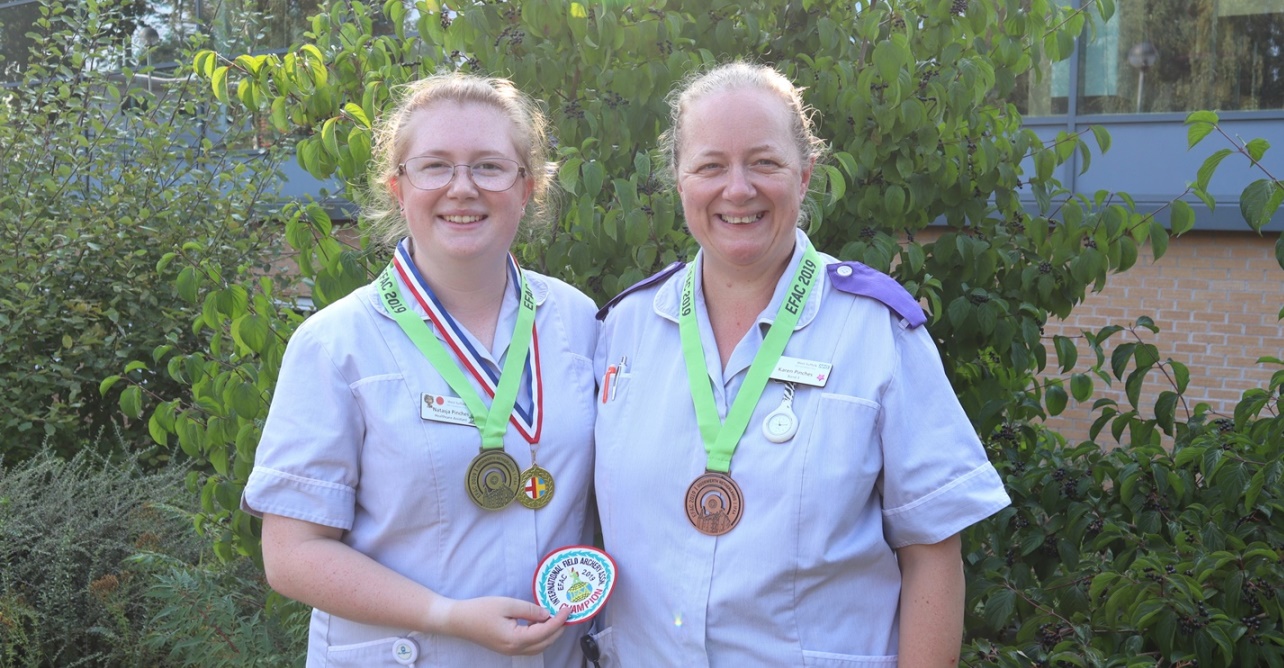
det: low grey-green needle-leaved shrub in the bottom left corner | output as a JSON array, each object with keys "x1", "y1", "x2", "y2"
[{"x1": 0, "y1": 443, "x2": 199, "y2": 668}]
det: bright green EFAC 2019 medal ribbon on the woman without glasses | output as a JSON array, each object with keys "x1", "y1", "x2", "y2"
[{"x1": 678, "y1": 243, "x2": 820, "y2": 473}]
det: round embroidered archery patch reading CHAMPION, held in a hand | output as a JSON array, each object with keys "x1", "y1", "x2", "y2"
[{"x1": 533, "y1": 545, "x2": 615, "y2": 624}]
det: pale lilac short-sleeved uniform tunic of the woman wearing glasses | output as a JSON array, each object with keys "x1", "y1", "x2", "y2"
[{"x1": 243, "y1": 262, "x2": 597, "y2": 668}]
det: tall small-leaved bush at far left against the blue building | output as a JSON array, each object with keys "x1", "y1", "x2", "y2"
[{"x1": 0, "y1": 0, "x2": 286, "y2": 462}]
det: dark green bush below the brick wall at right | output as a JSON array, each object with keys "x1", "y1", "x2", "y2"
[{"x1": 967, "y1": 317, "x2": 1284, "y2": 667}]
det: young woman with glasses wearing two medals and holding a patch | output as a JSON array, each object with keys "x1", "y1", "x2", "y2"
[{"x1": 244, "y1": 75, "x2": 596, "y2": 667}]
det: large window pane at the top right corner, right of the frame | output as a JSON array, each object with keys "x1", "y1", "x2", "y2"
[{"x1": 1079, "y1": 0, "x2": 1284, "y2": 113}]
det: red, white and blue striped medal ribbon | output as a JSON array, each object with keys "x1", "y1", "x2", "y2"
[{"x1": 393, "y1": 240, "x2": 544, "y2": 444}]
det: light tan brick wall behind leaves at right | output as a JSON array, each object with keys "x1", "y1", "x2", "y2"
[{"x1": 918, "y1": 230, "x2": 1284, "y2": 443}]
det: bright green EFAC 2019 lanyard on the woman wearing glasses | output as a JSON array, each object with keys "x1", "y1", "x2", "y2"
[{"x1": 379, "y1": 265, "x2": 535, "y2": 450}]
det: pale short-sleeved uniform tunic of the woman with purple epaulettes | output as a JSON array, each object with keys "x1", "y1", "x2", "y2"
[{"x1": 594, "y1": 231, "x2": 1009, "y2": 668}]
